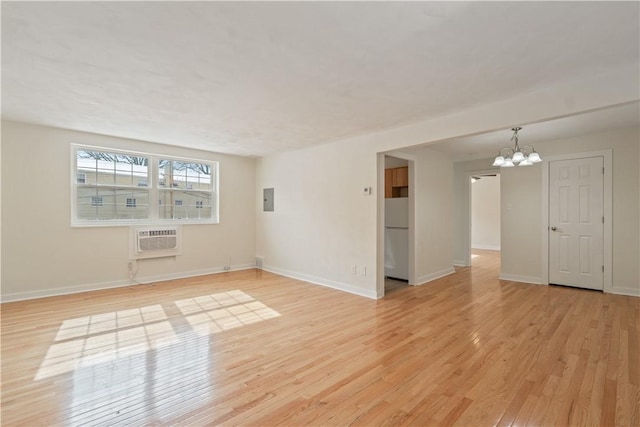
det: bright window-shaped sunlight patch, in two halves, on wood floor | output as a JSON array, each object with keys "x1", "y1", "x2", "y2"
[{"x1": 34, "y1": 290, "x2": 280, "y2": 381}]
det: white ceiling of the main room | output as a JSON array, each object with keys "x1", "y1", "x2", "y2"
[{"x1": 1, "y1": 1, "x2": 640, "y2": 156}]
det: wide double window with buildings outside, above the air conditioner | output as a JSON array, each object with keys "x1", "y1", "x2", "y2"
[{"x1": 71, "y1": 146, "x2": 218, "y2": 226}]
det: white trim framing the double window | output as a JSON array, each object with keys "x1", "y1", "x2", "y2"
[{"x1": 70, "y1": 144, "x2": 220, "y2": 227}]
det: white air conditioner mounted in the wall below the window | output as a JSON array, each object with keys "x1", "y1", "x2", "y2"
[{"x1": 129, "y1": 225, "x2": 182, "y2": 259}]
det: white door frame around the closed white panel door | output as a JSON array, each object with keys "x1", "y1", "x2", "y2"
[{"x1": 540, "y1": 149, "x2": 613, "y2": 292}]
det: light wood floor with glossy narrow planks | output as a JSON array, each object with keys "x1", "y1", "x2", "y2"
[{"x1": 2, "y1": 251, "x2": 640, "y2": 426}]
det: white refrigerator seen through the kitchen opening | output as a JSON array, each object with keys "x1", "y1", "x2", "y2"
[{"x1": 384, "y1": 197, "x2": 409, "y2": 280}]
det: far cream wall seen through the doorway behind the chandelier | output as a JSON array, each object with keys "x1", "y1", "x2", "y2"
[{"x1": 471, "y1": 176, "x2": 500, "y2": 251}]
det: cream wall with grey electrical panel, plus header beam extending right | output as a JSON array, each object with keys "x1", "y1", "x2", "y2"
[{"x1": 256, "y1": 67, "x2": 639, "y2": 297}]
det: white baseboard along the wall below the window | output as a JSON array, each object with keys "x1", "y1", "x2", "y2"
[{"x1": 0, "y1": 264, "x2": 256, "y2": 303}]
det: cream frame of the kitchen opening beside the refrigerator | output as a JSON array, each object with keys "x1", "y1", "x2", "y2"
[{"x1": 376, "y1": 151, "x2": 417, "y2": 298}]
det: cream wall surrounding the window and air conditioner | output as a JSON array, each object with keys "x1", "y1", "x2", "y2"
[{"x1": 2, "y1": 122, "x2": 256, "y2": 301}]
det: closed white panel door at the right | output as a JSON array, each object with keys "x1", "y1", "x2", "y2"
[{"x1": 549, "y1": 157, "x2": 604, "y2": 290}]
